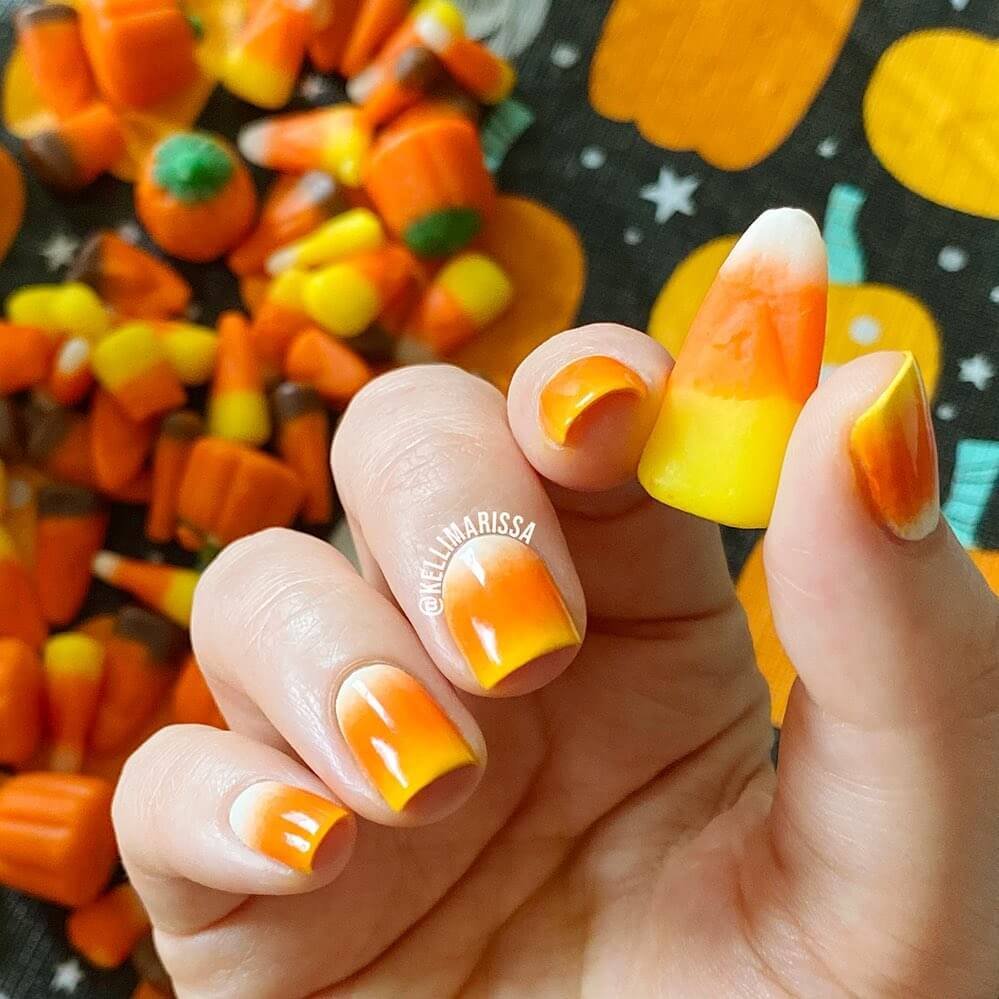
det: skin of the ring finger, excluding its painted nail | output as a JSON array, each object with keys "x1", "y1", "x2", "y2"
[{"x1": 191, "y1": 528, "x2": 486, "y2": 825}]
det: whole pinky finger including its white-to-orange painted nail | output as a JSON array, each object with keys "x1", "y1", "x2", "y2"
[{"x1": 113, "y1": 725, "x2": 356, "y2": 933}]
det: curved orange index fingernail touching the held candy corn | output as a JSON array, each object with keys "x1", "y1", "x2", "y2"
[{"x1": 539, "y1": 357, "x2": 648, "y2": 445}]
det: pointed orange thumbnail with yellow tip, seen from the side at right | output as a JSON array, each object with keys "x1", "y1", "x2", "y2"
[{"x1": 850, "y1": 354, "x2": 940, "y2": 541}]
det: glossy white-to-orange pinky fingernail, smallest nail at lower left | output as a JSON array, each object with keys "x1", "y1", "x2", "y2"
[{"x1": 229, "y1": 780, "x2": 350, "y2": 874}]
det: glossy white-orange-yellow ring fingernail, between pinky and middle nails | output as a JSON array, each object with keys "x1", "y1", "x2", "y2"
[{"x1": 335, "y1": 663, "x2": 478, "y2": 812}]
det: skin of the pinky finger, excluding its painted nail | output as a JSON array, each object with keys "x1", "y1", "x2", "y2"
[{"x1": 112, "y1": 725, "x2": 356, "y2": 932}]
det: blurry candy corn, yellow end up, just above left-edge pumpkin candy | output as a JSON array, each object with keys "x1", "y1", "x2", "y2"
[{"x1": 43, "y1": 631, "x2": 104, "y2": 773}]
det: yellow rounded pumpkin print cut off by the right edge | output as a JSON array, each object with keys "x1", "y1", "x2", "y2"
[{"x1": 864, "y1": 28, "x2": 999, "y2": 219}]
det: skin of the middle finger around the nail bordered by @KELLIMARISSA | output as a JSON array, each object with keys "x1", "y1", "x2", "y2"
[{"x1": 333, "y1": 365, "x2": 586, "y2": 696}]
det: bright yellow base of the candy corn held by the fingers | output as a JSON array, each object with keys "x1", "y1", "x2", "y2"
[{"x1": 638, "y1": 388, "x2": 800, "y2": 527}]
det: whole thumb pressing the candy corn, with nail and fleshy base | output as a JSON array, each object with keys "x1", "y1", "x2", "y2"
[{"x1": 748, "y1": 354, "x2": 999, "y2": 996}]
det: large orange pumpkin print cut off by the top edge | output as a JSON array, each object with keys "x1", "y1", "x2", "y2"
[{"x1": 590, "y1": 0, "x2": 860, "y2": 170}]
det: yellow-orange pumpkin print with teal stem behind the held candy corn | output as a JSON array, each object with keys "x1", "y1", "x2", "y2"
[{"x1": 649, "y1": 184, "x2": 940, "y2": 395}]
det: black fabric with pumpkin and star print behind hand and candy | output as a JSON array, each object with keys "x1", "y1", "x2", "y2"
[{"x1": 0, "y1": 0, "x2": 999, "y2": 999}]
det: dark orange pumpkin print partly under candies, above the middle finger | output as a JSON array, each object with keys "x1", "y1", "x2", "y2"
[{"x1": 458, "y1": 195, "x2": 586, "y2": 391}]
